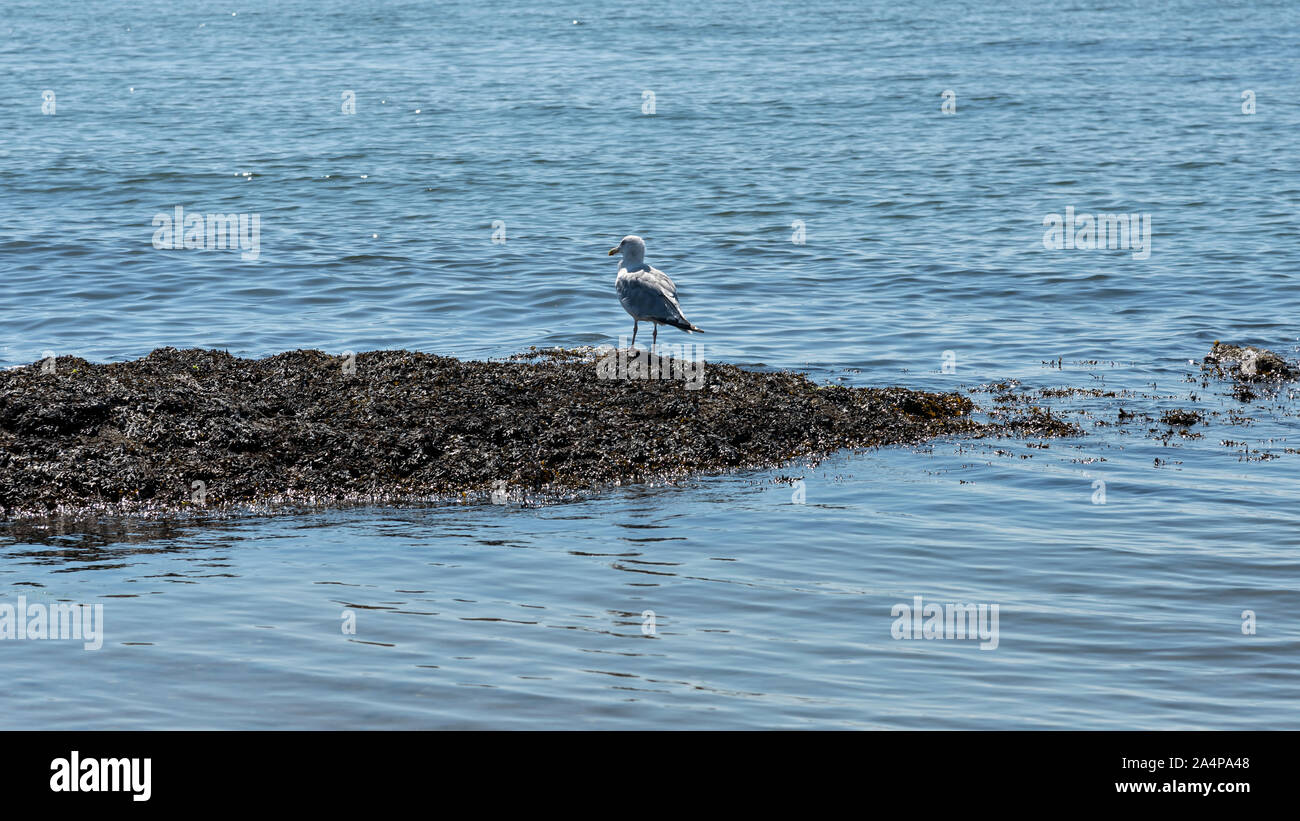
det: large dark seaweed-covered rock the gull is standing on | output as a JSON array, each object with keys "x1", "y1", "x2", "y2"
[{"x1": 0, "y1": 348, "x2": 1080, "y2": 520}]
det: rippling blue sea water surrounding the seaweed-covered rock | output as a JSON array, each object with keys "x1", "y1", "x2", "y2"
[{"x1": 0, "y1": 0, "x2": 1300, "y2": 729}]
